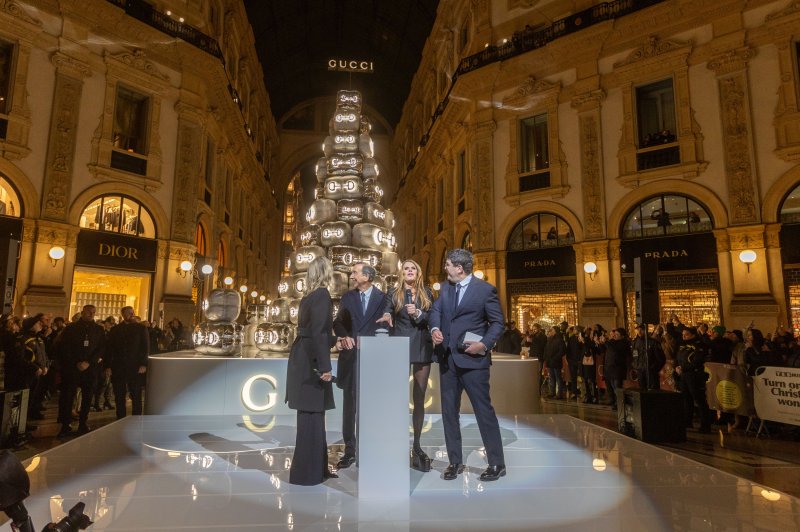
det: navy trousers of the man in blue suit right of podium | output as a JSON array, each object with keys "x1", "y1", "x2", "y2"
[{"x1": 439, "y1": 360, "x2": 506, "y2": 465}]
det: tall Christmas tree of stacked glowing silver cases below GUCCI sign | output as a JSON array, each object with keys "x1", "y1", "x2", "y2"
[{"x1": 194, "y1": 90, "x2": 399, "y2": 355}]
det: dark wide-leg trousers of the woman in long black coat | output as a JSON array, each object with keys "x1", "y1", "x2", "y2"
[{"x1": 289, "y1": 410, "x2": 328, "y2": 486}]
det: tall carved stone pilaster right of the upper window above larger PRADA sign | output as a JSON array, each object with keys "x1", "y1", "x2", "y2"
[{"x1": 708, "y1": 47, "x2": 760, "y2": 225}]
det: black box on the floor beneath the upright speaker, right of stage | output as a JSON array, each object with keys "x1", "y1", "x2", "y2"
[{"x1": 617, "y1": 388, "x2": 686, "y2": 443}]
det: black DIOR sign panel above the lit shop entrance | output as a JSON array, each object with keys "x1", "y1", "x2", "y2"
[{"x1": 75, "y1": 230, "x2": 158, "y2": 272}]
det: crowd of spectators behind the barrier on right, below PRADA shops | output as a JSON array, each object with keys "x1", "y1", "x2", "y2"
[{"x1": 512, "y1": 315, "x2": 800, "y2": 432}]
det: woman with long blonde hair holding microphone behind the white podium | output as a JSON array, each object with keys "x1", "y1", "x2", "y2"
[{"x1": 379, "y1": 259, "x2": 433, "y2": 471}]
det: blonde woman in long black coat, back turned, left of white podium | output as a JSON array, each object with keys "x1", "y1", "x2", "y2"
[{"x1": 286, "y1": 257, "x2": 336, "y2": 486}]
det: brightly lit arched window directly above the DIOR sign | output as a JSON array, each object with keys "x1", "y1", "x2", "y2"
[{"x1": 80, "y1": 194, "x2": 156, "y2": 238}]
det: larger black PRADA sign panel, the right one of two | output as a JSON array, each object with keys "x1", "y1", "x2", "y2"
[{"x1": 620, "y1": 233, "x2": 717, "y2": 273}]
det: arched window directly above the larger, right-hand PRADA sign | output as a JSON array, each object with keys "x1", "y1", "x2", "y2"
[{"x1": 622, "y1": 195, "x2": 714, "y2": 239}]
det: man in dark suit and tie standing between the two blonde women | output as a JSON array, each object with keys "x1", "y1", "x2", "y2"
[{"x1": 333, "y1": 262, "x2": 385, "y2": 469}]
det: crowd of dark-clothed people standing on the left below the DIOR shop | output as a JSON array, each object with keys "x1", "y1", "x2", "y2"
[{"x1": 0, "y1": 305, "x2": 185, "y2": 438}]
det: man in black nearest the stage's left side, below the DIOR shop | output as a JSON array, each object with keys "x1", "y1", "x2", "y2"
[{"x1": 103, "y1": 307, "x2": 150, "y2": 419}]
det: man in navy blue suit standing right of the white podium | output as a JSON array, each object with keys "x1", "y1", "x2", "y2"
[{"x1": 429, "y1": 249, "x2": 506, "y2": 481}]
